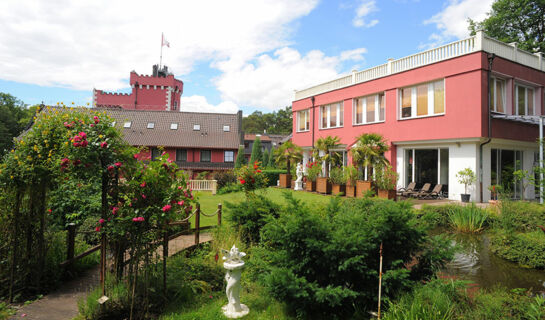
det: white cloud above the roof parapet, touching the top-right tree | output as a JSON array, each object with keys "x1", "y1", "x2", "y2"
[{"x1": 423, "y1": 0, "x2": 494, "y2": 47}]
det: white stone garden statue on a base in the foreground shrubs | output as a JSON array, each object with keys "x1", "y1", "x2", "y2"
[{"x1": 221, "y1": 245, "x2": 250, "y2": 318}]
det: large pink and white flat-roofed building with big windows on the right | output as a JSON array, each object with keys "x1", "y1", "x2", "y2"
[{"x1": 292, "y1": 32, "x2": 545, "y2": 201}]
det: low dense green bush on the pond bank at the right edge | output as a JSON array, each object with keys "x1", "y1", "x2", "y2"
[{"x1": 490, "y1": 230, "x2": 545, "y2": 269}]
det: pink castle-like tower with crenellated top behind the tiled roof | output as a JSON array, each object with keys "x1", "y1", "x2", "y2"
[{"x1": 93, "y1": 65, "x2": 184, "y2": 111}]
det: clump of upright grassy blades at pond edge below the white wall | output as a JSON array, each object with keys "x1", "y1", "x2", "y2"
[{"x1": 449, "y1": 203, "x2": 488, "y2": 232}]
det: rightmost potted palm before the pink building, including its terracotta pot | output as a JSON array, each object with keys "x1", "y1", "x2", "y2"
[{"x1": 350, "y1": 133, "x2": 390, "y2": 197}]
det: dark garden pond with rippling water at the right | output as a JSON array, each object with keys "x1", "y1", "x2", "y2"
[{"x1": 441, "y1": 233, "x2": 545, "y2": 291}]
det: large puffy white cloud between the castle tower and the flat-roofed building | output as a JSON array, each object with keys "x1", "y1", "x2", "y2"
[{"x1": 215, "y1": 47, "x2": 366, "y2": 110}]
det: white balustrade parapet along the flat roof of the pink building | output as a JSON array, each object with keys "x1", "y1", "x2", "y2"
[{"x1": 294, "y1": 31, "x2": 545, "y2": 101}]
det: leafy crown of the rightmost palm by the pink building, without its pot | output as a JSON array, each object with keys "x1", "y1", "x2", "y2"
[{"x1": 350, "y1": 133, "x2": 390, "y2": 180}]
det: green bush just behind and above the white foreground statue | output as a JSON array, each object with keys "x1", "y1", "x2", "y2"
[{"x1": 225, "y1": 194, "x2": 280, "y2": 244}]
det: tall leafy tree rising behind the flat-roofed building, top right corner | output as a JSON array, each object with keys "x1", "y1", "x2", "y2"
[{"x1": 469, "y1": 0, "x2": 545, "y2": 52}]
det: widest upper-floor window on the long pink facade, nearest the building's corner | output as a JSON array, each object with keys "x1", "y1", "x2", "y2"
[{"x1": 399, "y1": 80, "x2": 445, "y2": 119}]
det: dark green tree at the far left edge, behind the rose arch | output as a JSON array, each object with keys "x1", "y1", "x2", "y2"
[{"x1": 0, "y1": 92, "x2": 30, "y2": 156}]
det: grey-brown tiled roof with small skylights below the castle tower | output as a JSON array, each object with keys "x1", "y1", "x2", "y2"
[{"x1": 97, "y1": 109, "x2": 240, "y2": 149}]
